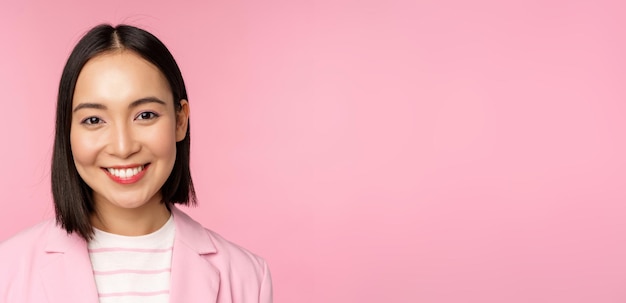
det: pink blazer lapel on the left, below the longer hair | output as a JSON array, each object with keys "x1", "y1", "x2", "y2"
[{"x1": 41, "y1": 226, "x2": 98, "y2": 303}]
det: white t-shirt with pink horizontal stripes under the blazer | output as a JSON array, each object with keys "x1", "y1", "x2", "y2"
[{"x1": 88, "y1": 216, "x2": 175, "y2": 303}]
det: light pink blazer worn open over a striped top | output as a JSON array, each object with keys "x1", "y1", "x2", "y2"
[{"x1": 0, "y1": 207, "x2": 272, "y2": 303}]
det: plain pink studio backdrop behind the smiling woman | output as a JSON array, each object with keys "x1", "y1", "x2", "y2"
[{"x1": 0, "y1": 0, "x2": 626, "y2": 303}]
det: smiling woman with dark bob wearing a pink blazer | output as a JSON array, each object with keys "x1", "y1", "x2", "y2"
[{"x1": 0, "y1": 25, "x2": 272, "y2": 303}]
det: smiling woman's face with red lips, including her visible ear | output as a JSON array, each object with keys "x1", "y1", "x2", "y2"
[{"x1": 70, "y1": 51, "x2": 189, "y2": 215}]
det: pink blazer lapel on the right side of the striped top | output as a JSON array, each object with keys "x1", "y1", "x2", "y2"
[{"x1": 170, "y1": 207, "x2": 220, "y2": 303}]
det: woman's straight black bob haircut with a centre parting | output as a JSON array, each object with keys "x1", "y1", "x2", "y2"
[{"x1": 51, "y1": 24, "x2": 196, "y2": 240}]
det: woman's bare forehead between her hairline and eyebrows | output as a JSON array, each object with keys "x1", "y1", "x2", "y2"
[{"x1": 72, "y1": 51, "x2": 172, "y2": 106}]
